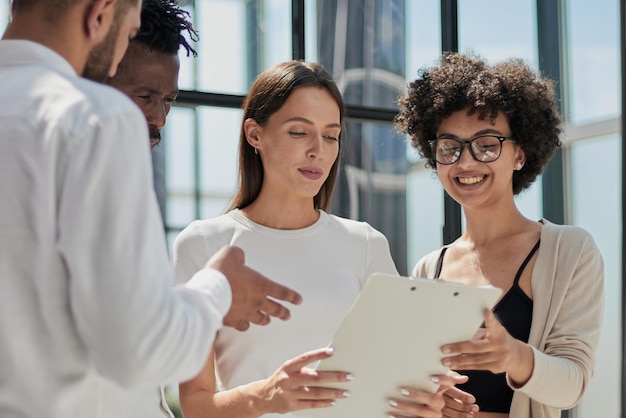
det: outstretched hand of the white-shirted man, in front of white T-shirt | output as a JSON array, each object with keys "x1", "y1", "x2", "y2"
[{"x1": 205, "y1": 246, "x2": 302, "y2": 331}]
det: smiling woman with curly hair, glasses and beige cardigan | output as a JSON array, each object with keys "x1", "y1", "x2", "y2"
[{"x1": 395, "y1": 53, "x2": 604, "y2": 418}]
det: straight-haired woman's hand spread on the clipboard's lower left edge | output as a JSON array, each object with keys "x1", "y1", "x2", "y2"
[{"x1": 250, "y1": 348, "x2": 352, "y2": 415}]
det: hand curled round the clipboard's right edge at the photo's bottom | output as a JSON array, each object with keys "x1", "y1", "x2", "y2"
[{"x1": 389, "y1": 373, "x2": 473, "y2": 418}]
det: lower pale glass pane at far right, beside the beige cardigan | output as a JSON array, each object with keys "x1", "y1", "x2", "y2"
[{"x1": 569, "y1": 135, "x2": 622, "y2": 418}]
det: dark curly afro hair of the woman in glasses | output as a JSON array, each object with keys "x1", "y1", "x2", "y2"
[{"x1": 394, "y1": 53, "x2": 561, "y2": 195}]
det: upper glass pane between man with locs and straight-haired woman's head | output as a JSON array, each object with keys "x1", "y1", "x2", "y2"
[{"x1": 181, "y1": 0, "x2": 291, "y2": 94}]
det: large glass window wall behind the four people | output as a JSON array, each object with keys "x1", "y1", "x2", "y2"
[{"x1": 0, "y1": 0, "x2": 623, "y2": 418}]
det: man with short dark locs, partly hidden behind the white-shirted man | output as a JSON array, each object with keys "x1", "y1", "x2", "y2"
[{"x1": 109, "y1": 0, "x2": 198, "y2": 148}]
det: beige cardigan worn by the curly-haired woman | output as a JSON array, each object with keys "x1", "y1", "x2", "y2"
[{"x1": 413, "y1": 220, "x2": 604, "y2": 418}]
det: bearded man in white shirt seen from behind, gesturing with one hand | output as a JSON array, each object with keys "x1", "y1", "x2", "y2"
[{"x1": 0, "y1": 0, "x2": 300, "y2": 418}]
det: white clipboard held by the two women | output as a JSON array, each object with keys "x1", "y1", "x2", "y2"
[{"x1": 294, "y1": 273, "x2": 502, "y2": 418}]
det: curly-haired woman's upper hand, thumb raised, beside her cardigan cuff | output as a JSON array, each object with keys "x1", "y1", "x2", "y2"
[{"x1": 441, "y1": 309, "x2": 534, "y2": 386}]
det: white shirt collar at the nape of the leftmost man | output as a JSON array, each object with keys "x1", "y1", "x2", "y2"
[{"x1": 0, "y1": 39, "x2": 77, "y2": 77}]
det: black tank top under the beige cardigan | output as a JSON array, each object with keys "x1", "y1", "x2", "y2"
[{"x1": 435, "y1": 241, "x2": 540, "y2": 413}]
